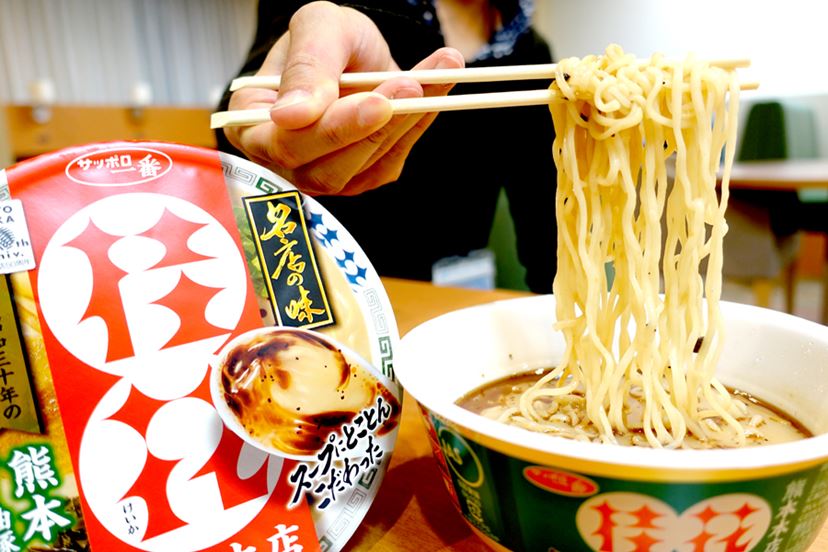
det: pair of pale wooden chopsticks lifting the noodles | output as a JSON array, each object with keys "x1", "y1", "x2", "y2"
[{"x1": 210, "y1": 59, "x2": 758, "y2": 128}]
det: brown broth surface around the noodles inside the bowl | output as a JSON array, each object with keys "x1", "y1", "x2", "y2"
[{"x1": 456, "y1": 371, "x2": 813, "y2": 448}]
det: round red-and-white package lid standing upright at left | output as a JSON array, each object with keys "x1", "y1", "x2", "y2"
[{"x1": 0, "y1": 142, "x2": 402, "y2": 552}]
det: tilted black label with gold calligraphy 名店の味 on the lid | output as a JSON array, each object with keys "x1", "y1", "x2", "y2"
[{"x1": 244, "y1": 191, "x2": 334, "y2": 328}]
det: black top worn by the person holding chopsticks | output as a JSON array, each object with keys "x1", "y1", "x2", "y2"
[{"x1": 217, "y1": 0, "x2": 556, "y2": 293}]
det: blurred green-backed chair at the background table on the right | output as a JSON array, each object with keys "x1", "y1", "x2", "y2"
[{"x1": 723, "y1": 101, "x2": 817, "y2": 312}]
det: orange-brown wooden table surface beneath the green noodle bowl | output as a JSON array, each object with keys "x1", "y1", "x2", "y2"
[{"x1": 346, "y1": 278, "x2": 828, "y2": 552}]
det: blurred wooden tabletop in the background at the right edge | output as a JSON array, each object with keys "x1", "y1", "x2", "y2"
[{"x1": 730, "y1": 158, "x2": 828, "y2": 190}]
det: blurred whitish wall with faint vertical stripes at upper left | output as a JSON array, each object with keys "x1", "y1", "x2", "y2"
[{"x1": 0, "y1": 0, "x2": 258, "y2": 106}]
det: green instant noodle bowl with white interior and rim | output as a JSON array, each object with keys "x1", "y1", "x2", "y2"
[{"x1": 396, "y1": 295, "x2": 828, "y2": 552}]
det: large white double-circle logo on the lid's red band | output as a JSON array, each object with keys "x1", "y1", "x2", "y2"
[{"x1": 38, "y1": 193, "x2": 282, "y2": 550}]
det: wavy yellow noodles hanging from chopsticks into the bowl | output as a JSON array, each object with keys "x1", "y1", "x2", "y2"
[{"x1": 486, "y1": 45, "x2": 755, "y2": 447}]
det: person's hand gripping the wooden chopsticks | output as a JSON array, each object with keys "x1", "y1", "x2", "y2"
[{"x1": 224, "y1": 2, "x2": 464, "y2": 195}]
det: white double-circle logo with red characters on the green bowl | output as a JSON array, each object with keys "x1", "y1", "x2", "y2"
[{"x1": 575, "y1": 492, "x2": 771, "y2": 552}]
